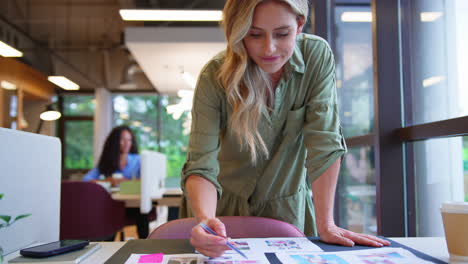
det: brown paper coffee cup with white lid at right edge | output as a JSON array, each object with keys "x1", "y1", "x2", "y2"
[{"x1": 440, "y1": 202, "x2": 468, "y2": 262}]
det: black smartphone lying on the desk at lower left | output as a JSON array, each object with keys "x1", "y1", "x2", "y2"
[{"x1": 20, "y1": 240, "x2": 89, "y2": 258}]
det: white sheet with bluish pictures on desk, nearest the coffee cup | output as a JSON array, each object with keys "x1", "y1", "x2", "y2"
[{"x1": 276, "y1": 247, "x2": 432, "y2": 264}]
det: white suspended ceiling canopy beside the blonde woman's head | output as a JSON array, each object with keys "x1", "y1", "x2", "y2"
[{"x1": 125, "y1": 27, "x2": 226, "y2": 94}]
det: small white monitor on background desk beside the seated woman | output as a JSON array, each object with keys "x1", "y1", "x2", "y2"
[{"x1": 140, "y1": 150, "x2": 167, "y2": 214}]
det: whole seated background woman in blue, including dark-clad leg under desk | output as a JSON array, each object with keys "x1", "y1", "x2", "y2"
[{"x1": 83, "y1": 126, "x2": 152, "y2": 238}]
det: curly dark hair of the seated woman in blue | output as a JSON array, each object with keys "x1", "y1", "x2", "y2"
[{"x1": 98, "y1": 126, "x2": 138, "y2": 177}]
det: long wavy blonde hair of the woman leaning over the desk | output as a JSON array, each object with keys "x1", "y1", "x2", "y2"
[{"x1": 218, "y1": 0, "x2": 309, "y2": 164}]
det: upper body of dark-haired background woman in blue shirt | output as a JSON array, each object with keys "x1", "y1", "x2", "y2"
[{"x1": 83, "y1": 126, "x2": 140, "y2": 186}]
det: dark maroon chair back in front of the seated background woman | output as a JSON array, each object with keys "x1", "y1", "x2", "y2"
[{"x1": 60, "y1": 181, "x2": 125, "y2": 240}]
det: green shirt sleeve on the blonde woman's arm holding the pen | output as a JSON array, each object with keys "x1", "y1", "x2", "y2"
[{"x1": 181, "y1": 61, "x2": 222, "y2": 197}]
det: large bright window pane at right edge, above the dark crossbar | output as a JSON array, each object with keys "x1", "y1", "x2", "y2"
[{"x1": 403, "y1": 0, "x2": 468, "y2": 125}]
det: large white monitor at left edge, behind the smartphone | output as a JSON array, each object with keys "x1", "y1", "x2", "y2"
[{"x1": 0, "y1": 128, "x2": 61, "y2": 255}]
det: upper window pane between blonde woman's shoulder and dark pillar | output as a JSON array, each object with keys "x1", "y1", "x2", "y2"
[{"x1": 335, "y1": 5, "x2": 374, "y2": 137}]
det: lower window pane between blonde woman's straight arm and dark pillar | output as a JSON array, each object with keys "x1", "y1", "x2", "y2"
[{"x1": 337, "y1": 146, "x2": 377, "y2": 235}]
